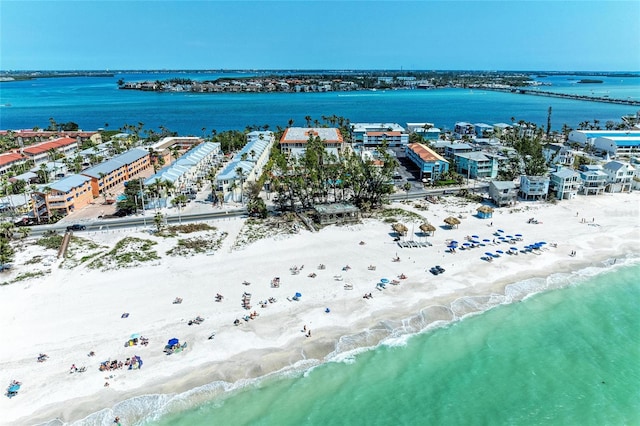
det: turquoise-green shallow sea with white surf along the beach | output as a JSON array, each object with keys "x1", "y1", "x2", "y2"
[{"x1": 79, "y1": 260, "x2": 640, "y2": 426}]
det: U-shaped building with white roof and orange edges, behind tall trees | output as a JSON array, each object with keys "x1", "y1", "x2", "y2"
[{"x1": 280, "y1": 127, "x2": 345, "y2": 157}]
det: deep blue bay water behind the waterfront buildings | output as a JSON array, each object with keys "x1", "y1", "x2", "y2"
[{"x1": 0, "y1": 73, "x2": 640, "y2": 136}]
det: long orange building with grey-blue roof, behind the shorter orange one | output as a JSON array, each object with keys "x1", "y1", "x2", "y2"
[{"x1": 82, "y1": 148, "x2": 151, "y2": 198}]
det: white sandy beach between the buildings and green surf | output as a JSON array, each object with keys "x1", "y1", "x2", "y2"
[{"x1": 0, "y1": 192, "x2": 640, "y2": 424}]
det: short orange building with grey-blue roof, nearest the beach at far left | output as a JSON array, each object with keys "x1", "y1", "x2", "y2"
[{"x1": 32, "y1": 175, "x2": 94, "y2": 220}]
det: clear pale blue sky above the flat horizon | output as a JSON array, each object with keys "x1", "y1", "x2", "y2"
[{"x1": 0, "y1": 0, "x2": 640, "y2": 71}]
